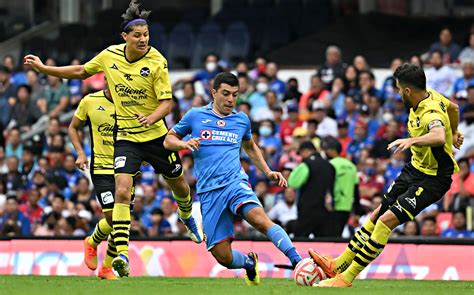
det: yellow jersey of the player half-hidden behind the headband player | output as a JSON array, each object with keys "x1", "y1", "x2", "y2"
[{"x1": 74, "y1": 91, "x2": 115, "y2": 174}]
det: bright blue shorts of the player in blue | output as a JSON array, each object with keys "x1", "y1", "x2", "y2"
[{"x1": 198, "y1": 180, "x2": 262, "y2": 251}]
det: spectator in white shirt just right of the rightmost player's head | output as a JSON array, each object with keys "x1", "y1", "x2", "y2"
[{"x1": 426, "y1": 51, "x2": 457, "y2": 97}]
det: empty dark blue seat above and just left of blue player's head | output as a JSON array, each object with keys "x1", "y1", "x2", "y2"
[{"x1": 191, "y1": 22, "x2": 223, "y2": 68}]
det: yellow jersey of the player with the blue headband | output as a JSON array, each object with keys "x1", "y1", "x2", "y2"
[{"x1": 84, "y1": 44, "x2": 172, "y2": 142}]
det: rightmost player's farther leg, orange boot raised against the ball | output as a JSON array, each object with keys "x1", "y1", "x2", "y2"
[{"x1": 308, "y1": 168, "x2": 411, "y2": 278}]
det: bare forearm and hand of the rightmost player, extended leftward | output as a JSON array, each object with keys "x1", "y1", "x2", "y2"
[{"x1": 387, "y1": 126, "x2": 446, "y2": 153}]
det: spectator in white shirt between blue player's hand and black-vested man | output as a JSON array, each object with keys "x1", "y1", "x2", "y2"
[{"x1": 267, "y1": 188, "x2": 298, "y2": 227}]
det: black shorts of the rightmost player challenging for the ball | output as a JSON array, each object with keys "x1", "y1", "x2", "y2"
[{"x1": 386, "y1": 163, "x2": 452, "y2": 224}]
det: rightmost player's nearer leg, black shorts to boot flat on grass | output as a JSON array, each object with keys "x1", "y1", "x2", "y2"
[{"x1": 319, "y1": 177, "x2": 451, "y2": 287}]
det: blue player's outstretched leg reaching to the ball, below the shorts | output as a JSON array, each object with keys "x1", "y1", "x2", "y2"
[{"x1": 243, "y1": 203, "x2": 301, "y2": 266}]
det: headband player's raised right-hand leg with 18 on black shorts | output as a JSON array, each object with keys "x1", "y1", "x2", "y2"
[{"x1": 153, "y1": 138, "x2": 204, "y2": 243}]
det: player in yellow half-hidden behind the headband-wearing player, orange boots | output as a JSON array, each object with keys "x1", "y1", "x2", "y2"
[{"x1": 68, "y1": 85, "x2": 121, "y2": 280}]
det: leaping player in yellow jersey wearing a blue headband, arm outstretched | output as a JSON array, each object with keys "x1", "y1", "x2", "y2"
[{"x1": 24, "y1": 0, "x2": 204, "y2": 276}]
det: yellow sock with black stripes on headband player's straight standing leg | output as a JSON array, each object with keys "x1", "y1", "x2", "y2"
[{"x1": 112, "y1": 203, "x2": 130, "y2": 257}]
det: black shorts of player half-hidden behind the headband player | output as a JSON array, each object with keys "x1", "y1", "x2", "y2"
[{"x1": 91, "y1": 174, "x2": 135, "y2": 212}]
